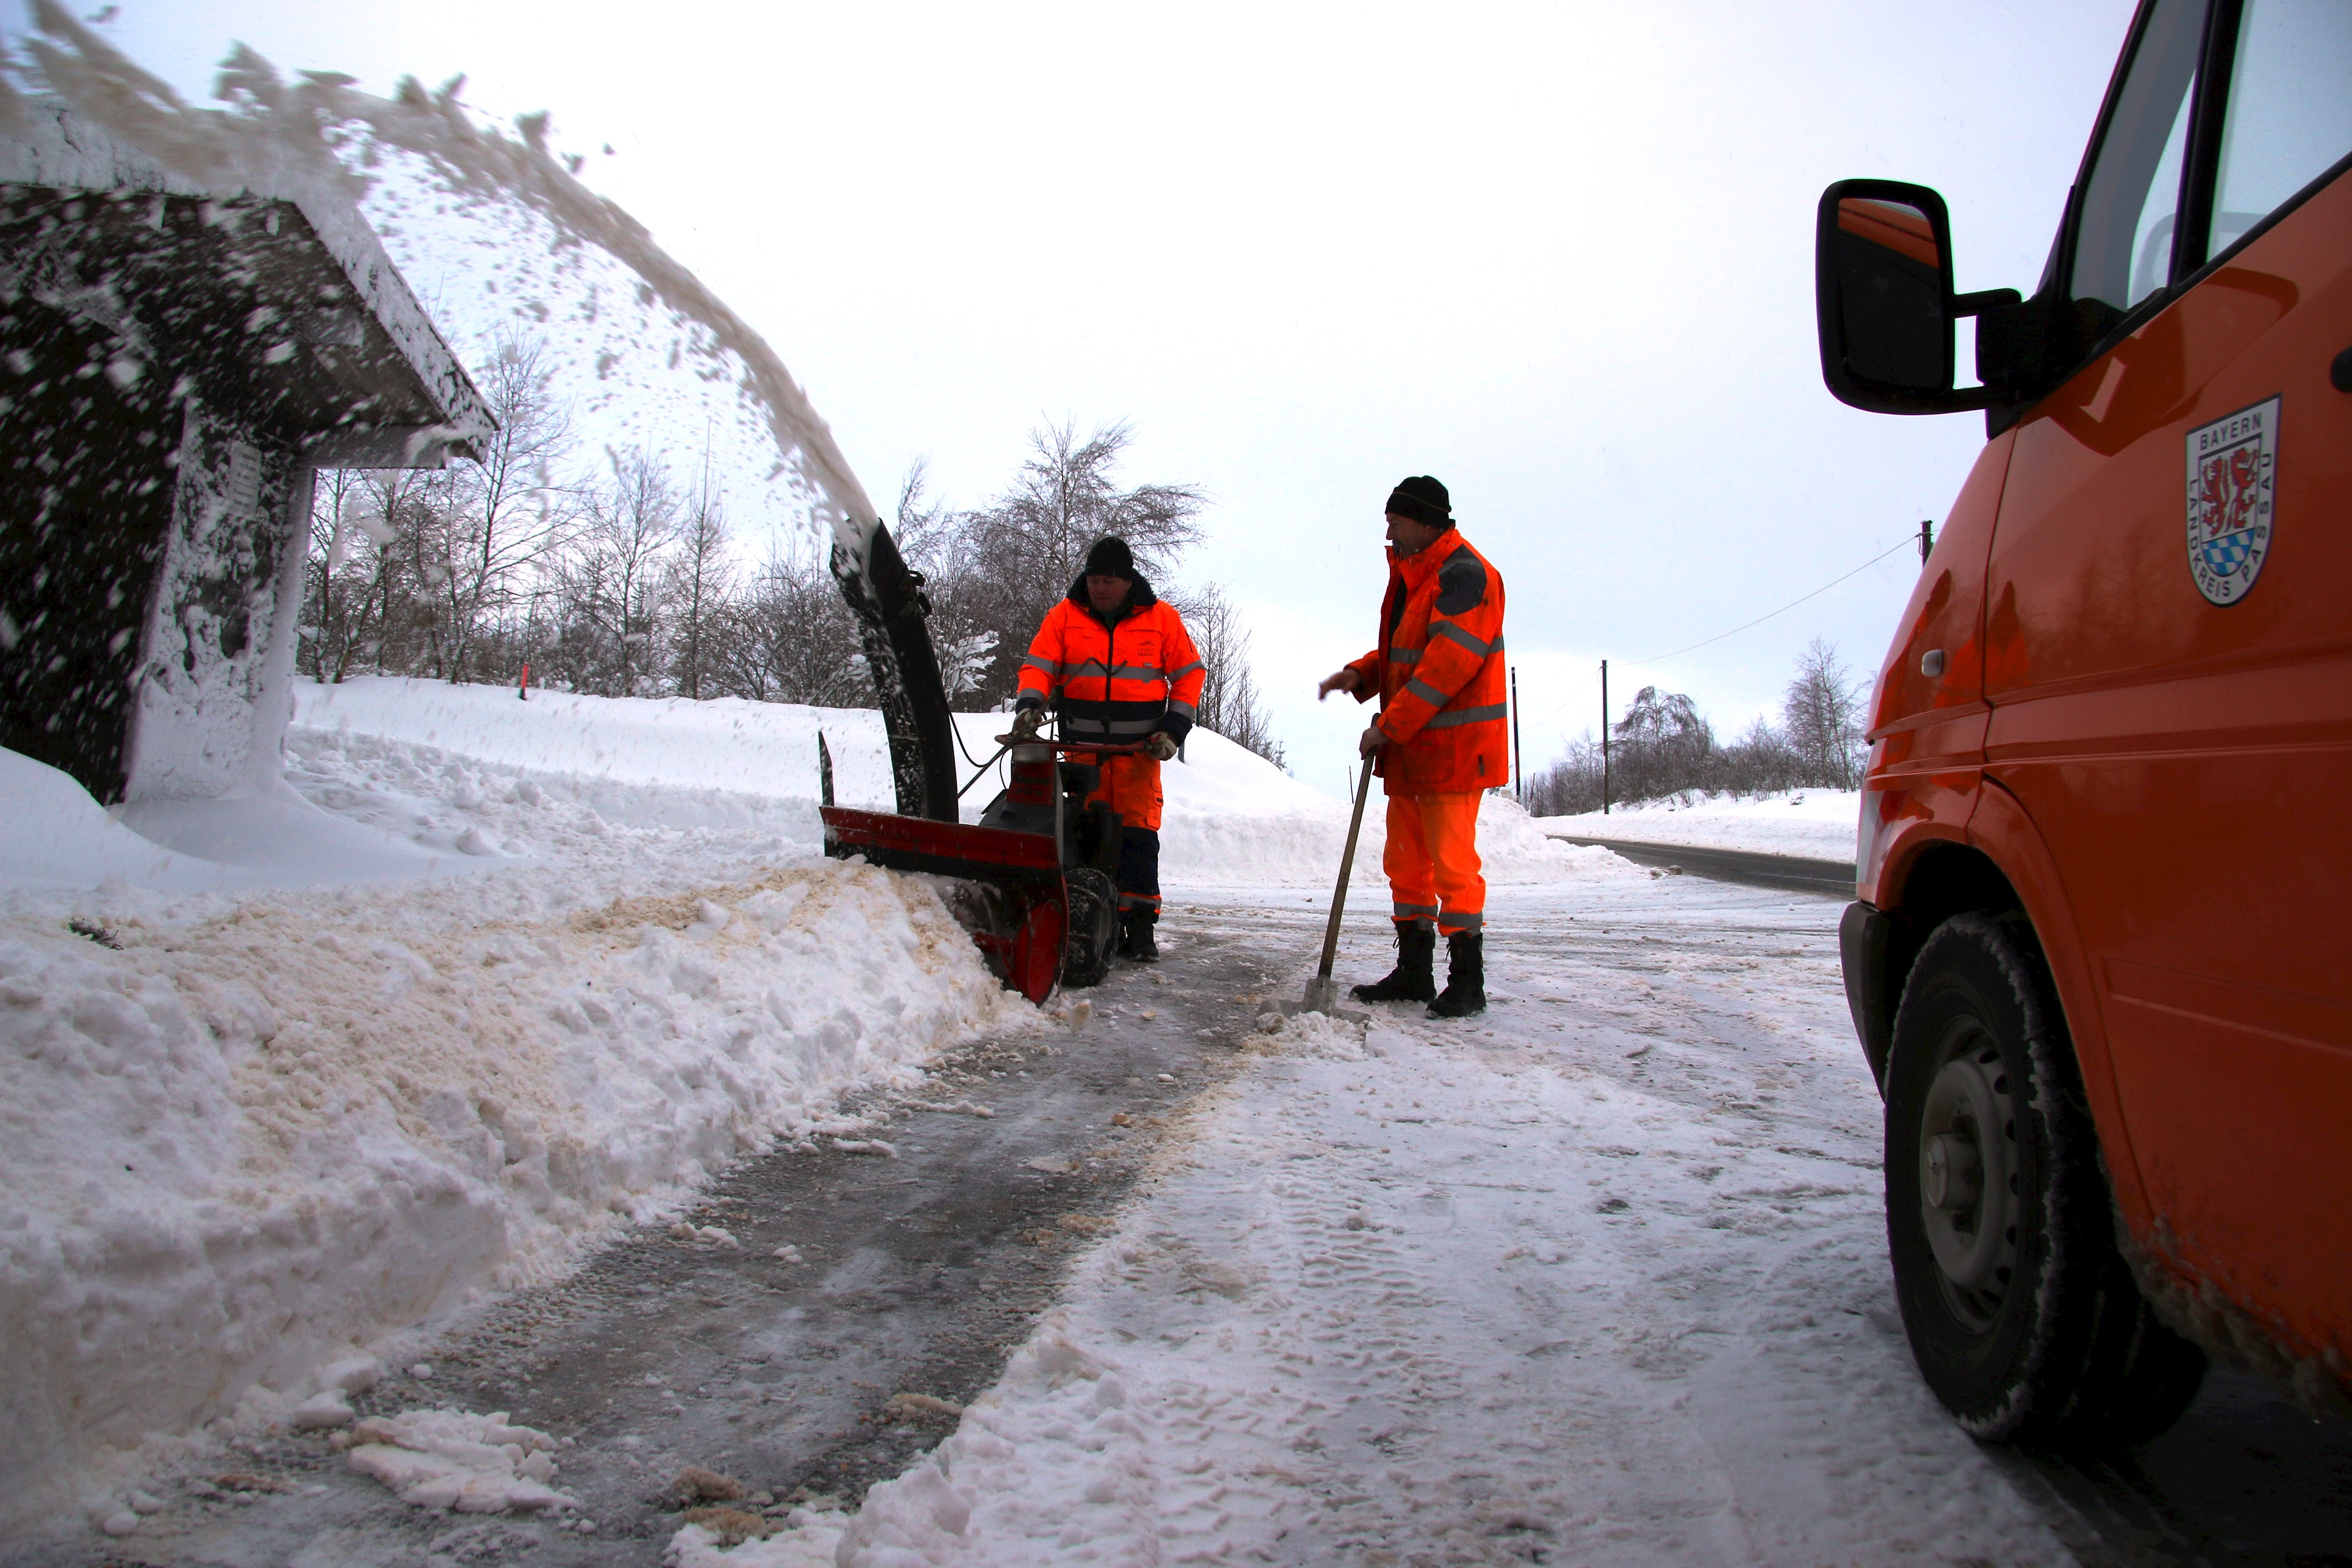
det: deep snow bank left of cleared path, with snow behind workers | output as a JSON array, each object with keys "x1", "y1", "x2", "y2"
[{"x1": 0, "y1": 679, "x2": 1595, "y2": 1516}]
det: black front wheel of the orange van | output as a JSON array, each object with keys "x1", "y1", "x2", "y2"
[{"x1": 1886, "y1": 912, "x2": 2204, "y2": 1448}]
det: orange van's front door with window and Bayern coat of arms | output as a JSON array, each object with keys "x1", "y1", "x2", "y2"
[{"x1": 1985, "y1": 0, "x2": 2352, "y2": 1354}]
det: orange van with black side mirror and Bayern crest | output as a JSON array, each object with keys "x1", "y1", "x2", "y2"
[{"x1": 1816, "y1": 0, "x2": 2352, "y2": 1441}]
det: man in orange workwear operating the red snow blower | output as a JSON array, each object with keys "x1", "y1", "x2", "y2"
[{"x1": 1013, "y1": 539, "x2": 1209, "y2": 964}]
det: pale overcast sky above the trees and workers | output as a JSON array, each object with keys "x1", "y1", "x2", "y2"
[{"x1": 64, "y1": 0, "x2": 2131, "y2": 795}]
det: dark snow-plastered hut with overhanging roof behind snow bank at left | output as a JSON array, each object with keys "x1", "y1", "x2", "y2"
[{"x1": 0, "y1": 103, "x2": 492, "y2": 802}]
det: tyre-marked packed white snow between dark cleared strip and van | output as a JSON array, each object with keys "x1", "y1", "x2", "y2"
[{"x1": 719, "y1": 872, "x2": 2072, "y2": 1568}]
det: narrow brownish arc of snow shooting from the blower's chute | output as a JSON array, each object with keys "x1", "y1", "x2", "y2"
[{"x1": 16, "y1": 0, "x2": 880, "y2": 555}]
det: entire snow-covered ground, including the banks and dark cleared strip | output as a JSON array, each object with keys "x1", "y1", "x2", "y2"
[{"x1": 0, "y1": 682, "x2": 2352, "y2": 1568}]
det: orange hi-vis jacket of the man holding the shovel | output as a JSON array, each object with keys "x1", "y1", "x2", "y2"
[{"x1": 1348, "y1": 529, "x2": 1510, "y2": 795}]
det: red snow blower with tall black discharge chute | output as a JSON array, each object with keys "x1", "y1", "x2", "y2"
[{"x1": 818, "y1": 522, "x2": 1138, "y2": 1001}]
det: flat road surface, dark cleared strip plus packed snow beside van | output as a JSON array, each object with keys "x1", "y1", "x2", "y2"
[{"x1": 22, "y1": 877, "x2": 2352, "y2": 1568}]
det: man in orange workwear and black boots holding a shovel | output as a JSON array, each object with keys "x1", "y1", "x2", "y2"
[{"x1": 1315, "y1": 475, "x2": 1510, "y2": 1018}]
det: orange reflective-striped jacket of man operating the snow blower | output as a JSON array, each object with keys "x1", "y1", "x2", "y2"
[{"x1": 1013, "y1": 578, "x2": 1209, "y2": 745}]
